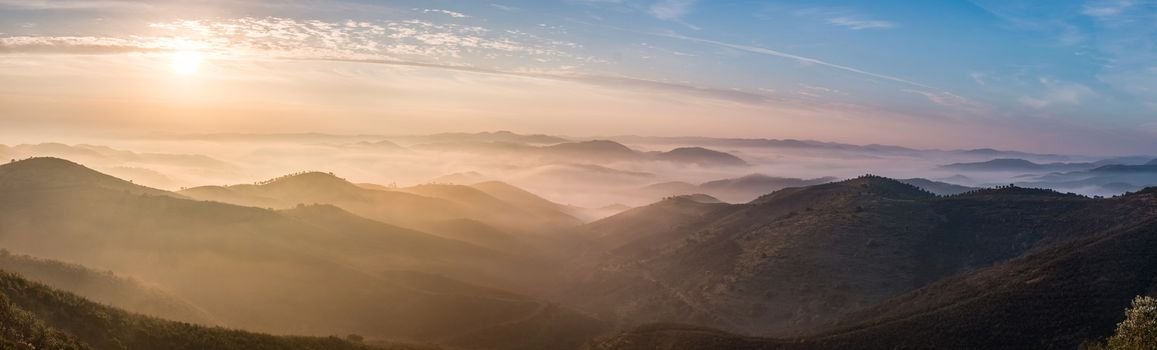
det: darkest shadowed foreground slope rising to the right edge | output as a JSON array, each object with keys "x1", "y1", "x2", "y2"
[{"x1": 592, "y1": 207, "x2": 1157, "y2": 350}]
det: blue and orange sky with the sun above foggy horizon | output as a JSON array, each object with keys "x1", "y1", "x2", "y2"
[{"x1": 0, "y1": 0, "x2": 1157, "y2": 155}]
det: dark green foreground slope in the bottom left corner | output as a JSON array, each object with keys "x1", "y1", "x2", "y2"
[{"x1": 0, "y1": 271, "x2": 433, "y2": 350}]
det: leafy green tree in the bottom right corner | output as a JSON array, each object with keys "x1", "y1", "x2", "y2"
[{"x1": 1090, "y1": 296, "x2": 1157, "y2": 350}]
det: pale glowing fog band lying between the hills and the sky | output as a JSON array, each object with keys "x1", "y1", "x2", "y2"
[{"x1": 0, "y1": 133, "x2": 1151, "y2": 208}]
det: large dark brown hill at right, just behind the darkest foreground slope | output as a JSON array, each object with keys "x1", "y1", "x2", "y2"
[{"x1": 568, "y1": 177, "x2": 1157, "y2": 336}]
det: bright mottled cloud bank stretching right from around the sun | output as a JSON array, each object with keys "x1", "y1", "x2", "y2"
[{"x1": 0, "y1": 17, "x2": 591, "y2": 68}]
